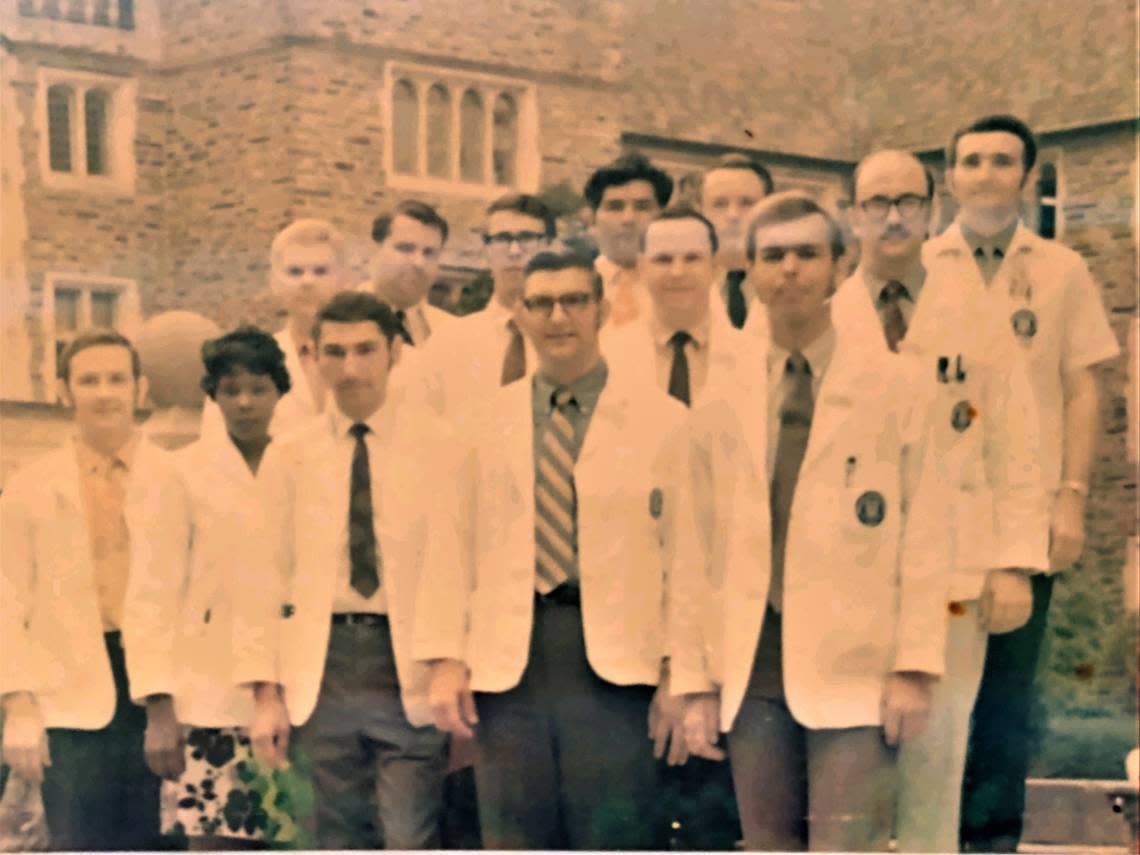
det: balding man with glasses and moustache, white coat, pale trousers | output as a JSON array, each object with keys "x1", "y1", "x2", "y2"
[{"x1": 833, "y1": 150, "x2": 1049, "y2": 852}]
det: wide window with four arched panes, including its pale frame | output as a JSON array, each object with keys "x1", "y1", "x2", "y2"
[{"x1": 383, "y1": 63, "x2": 539, "y2": 196}]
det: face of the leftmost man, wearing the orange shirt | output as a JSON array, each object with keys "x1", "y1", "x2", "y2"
[{"x1": 60, "y1": 344, "x2": 141, "y2": 435}]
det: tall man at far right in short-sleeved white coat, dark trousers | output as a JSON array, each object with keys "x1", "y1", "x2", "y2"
[{"x1": 925, "y1": 115, "x2": 1119, "y2": 852}]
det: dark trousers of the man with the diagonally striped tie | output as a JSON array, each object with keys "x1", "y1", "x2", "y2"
[{"x1": 475, "y1": 601, "x2": 663, "y2": 849}]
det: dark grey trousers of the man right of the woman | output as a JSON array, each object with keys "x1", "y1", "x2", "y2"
[{"x1": 294, "y1": 619, "x2": 447, "y2": 849}]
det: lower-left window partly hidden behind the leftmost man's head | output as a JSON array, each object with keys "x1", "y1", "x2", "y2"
[{"x1": 43, "y1": 274, "x2": 141, "y2": 389}]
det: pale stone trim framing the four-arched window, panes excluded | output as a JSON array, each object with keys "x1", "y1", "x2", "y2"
[{"x1": 381, "y1": 62, "x2": 542, "y2": 200}]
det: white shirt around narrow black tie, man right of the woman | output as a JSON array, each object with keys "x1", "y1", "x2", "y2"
[{"x1": 328, "y1": 406, "x2": 394, "y2": 614}]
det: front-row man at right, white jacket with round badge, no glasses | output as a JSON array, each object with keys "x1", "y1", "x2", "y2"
[{"x1": 669, "y1": 193, "x2": 947, "y2": 850}]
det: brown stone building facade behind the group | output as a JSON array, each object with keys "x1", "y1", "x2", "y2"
[{"x1": 0, "y1": 0, "x2": 1138, "y2": 738}]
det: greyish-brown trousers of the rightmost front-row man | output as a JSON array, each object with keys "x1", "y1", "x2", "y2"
[{"x1": 728, "y1": 609, "x2": 896, "y2": 852}]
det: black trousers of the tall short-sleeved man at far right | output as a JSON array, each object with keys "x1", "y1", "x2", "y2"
[{"x1": 960, "y1": 575, "x2": 1053, "y2": 852}]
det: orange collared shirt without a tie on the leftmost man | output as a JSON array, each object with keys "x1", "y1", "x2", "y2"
[{"x1": 75, "y1": 433, "x2": 138, "y2": 633}]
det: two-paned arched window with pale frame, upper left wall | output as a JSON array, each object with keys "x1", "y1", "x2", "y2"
[{"x1": 39, "y1": 68, "x2": 138, "y2": 193}]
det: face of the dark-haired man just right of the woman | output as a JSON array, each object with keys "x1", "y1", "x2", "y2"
[{"x1": 317, "y1": 320, "x2": 396, "y2": 421}]
